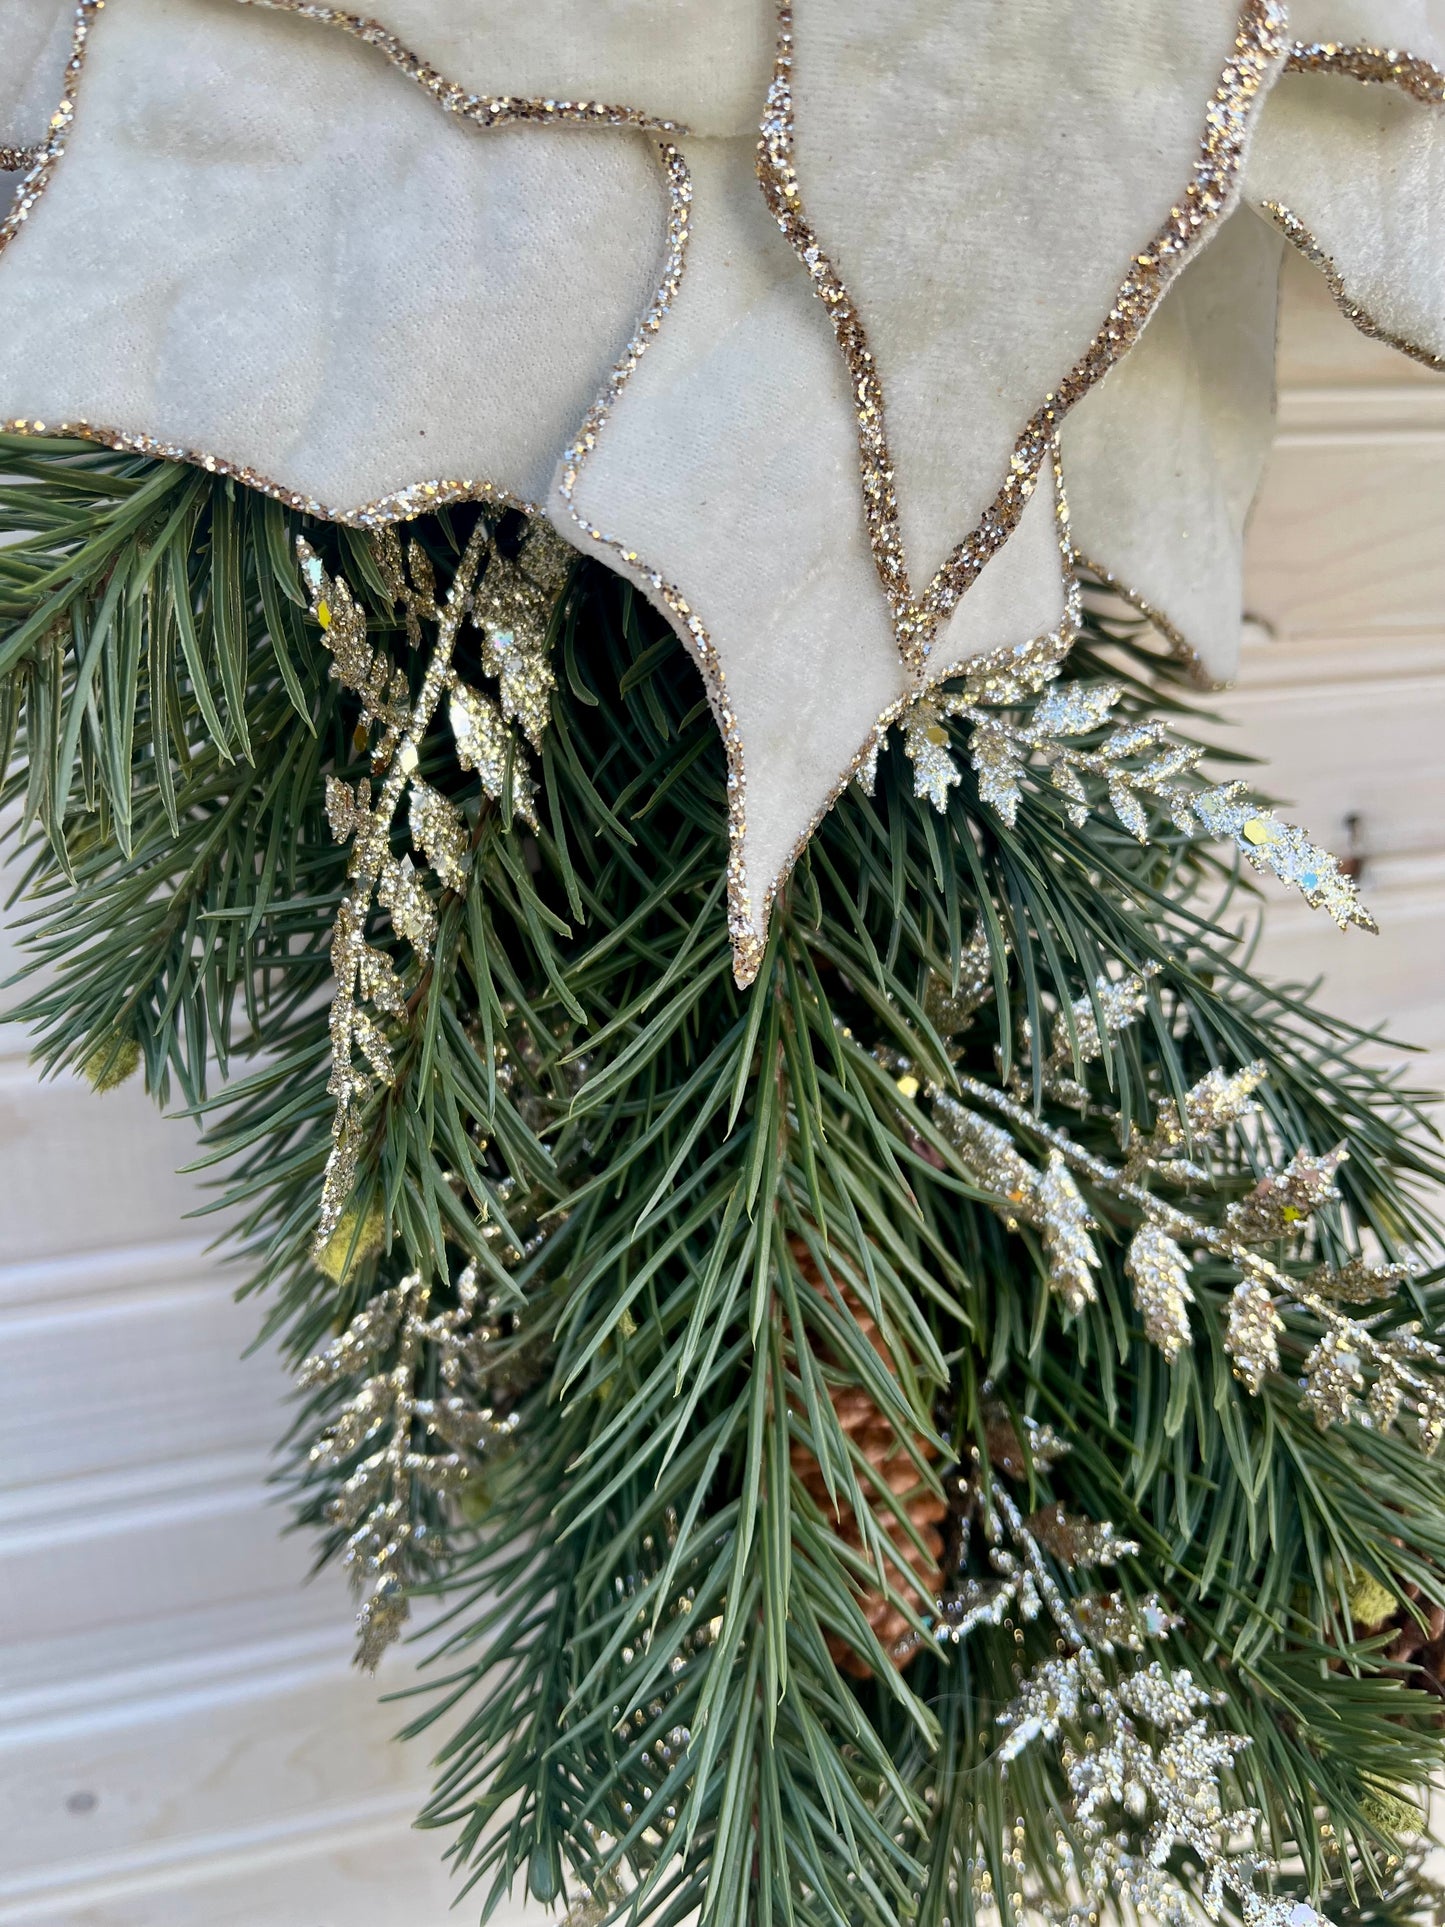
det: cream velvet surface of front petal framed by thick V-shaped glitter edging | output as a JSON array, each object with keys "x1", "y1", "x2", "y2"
[{"x1": 792, "y1": 0, "x2": 1287, "y2": 594}]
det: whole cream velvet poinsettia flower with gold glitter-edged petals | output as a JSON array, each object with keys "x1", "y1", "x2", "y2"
[{"x1": 0, "y1": 0, "x2": 1445, "y2": 977}]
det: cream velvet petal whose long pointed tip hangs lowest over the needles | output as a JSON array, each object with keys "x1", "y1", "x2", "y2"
[{"x1": 553, "y1": 141, "x2": 1062, "y2": 963}]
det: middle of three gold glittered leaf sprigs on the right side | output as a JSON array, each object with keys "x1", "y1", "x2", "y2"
[{"x1": 909, "y1": 954, "x2": 1445, "y2": 1451}]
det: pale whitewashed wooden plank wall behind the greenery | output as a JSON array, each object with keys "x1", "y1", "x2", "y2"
[{"x1": 0, "y1": 248, "x2": 1445, "y2": 1927}]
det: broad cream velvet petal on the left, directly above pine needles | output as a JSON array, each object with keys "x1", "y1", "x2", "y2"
[{"x1": 0, "y1": 0, "x2": 667, "y2": 513}]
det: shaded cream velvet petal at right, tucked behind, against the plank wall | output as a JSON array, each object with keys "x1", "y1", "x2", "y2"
[{"x1": 1060, "y1": 208, "x2": 1285, "y2": 682}]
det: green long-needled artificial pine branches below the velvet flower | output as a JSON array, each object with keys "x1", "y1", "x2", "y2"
[{"x1": 0, "y1": 441, "x2": 1445, "y2": 1927}]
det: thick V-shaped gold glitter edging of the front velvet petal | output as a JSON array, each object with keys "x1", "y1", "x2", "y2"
[{"x1": 757, "y1": 0, "x2": 1287, "y2": 669}]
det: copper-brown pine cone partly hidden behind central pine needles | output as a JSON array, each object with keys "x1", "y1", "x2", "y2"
[{"x1": 788, "y1": 1237, "x2": 948, "y2": 1680}]
